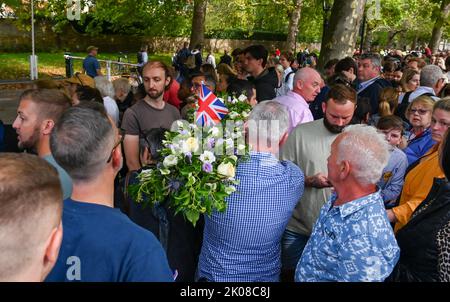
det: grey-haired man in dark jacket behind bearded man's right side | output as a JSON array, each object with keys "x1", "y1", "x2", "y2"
[{"x1": 358, "y1": 53, "x2": 392, "y2": 114}]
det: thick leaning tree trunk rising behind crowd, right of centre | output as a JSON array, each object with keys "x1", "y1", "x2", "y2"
[{"x1": 317, "y1": 0, "x2": 366, "y2": 71}]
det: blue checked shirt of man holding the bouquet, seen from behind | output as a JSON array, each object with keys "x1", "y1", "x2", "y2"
[{"x1": 198, "y1": 152, "x2": 304, "y2": 282}]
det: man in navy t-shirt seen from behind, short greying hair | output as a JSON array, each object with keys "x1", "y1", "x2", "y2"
[{"x1": 47, "y1": 105, "x2": 173, "y2": 282}]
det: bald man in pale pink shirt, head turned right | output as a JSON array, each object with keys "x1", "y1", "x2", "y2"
[{"x1": 276, "y1": 67, "x2": 322, "y2": 133}]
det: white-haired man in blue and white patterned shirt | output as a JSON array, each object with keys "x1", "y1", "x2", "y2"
[{"x1": 295, "y1": 125, "x2": 400, "y2": 282}]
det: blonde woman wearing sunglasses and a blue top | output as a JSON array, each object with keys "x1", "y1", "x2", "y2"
[{"x1": 403, "y1": 95, "x2": 436, "y2": 165}]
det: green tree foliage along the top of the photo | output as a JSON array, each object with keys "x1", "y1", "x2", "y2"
[{"x1": 0, "y1": 0, "x2": 450, "y2": 47}]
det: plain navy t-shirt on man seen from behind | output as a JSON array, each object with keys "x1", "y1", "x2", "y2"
[{"x1": 46, "y1": 199, "x2": 173, "y2": 282}]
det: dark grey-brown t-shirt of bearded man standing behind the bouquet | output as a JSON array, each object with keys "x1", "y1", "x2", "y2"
[{"x1": 122, "y1": 100, "x2": 181, "y2": 135}]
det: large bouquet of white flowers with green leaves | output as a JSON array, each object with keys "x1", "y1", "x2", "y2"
[{"x1": 129, "y1": 95, "x2": 251, "y2": 225}]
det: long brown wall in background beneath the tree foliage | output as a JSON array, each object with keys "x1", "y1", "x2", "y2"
[{"x1": 0, "y1": 19, "x2": 320, "y2": 53}]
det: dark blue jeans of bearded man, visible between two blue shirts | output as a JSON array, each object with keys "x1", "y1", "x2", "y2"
[{"x1": 281, "y1": 230, "x2": 309, "y2": 270}]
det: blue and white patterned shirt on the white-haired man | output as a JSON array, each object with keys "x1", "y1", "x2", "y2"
[{"x1": 295, "y1": 192, "x2": 400, "y2": 282}]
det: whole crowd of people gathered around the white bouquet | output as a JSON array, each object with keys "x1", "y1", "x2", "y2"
[{"x1": 0, "y1": 43, "x2": 450, "y2": 282}]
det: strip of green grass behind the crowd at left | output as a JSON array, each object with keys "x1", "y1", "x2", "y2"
[{"x1": 0, "y1": 52, "x2": 171, "y2": 80}]
